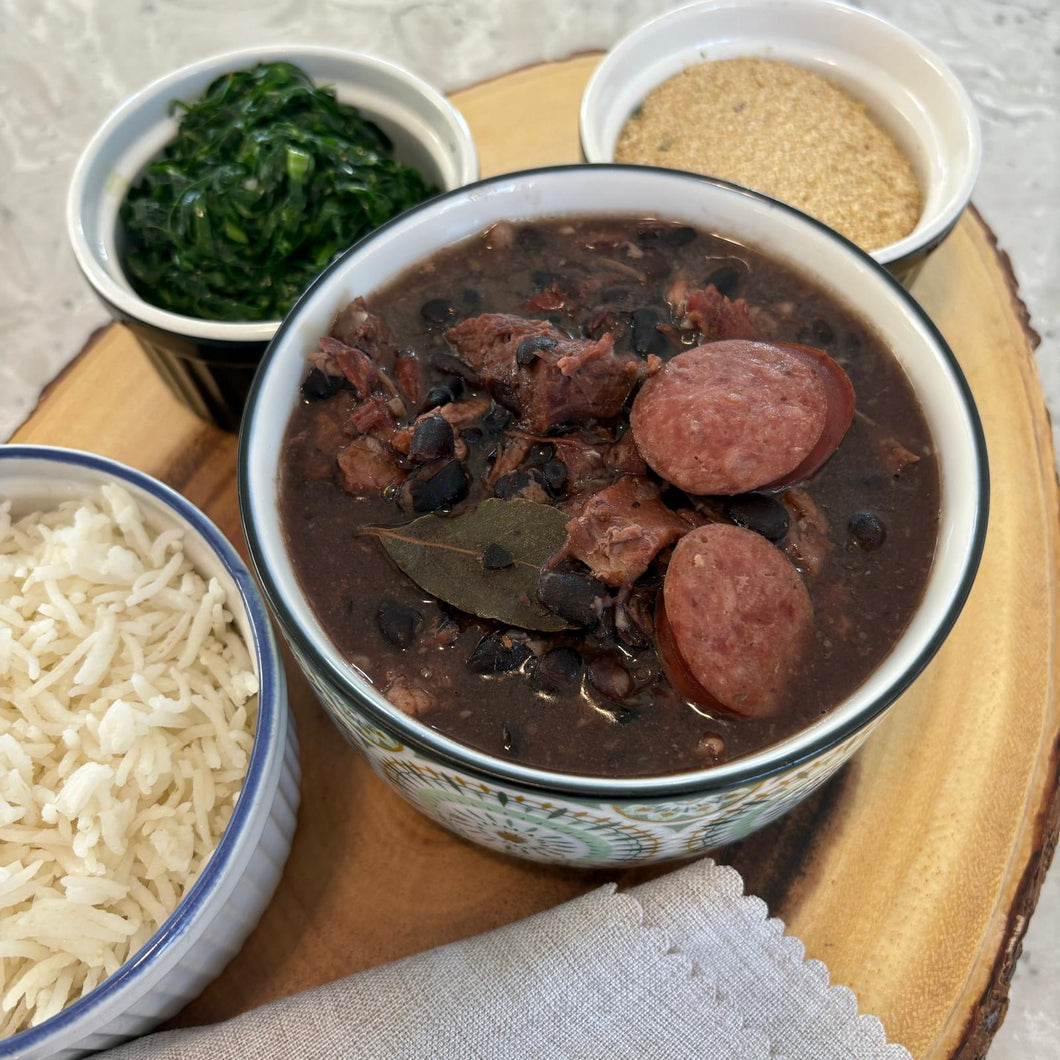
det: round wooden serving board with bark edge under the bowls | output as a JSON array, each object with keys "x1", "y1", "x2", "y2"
[{"x1": 16, "y1": 56, "x2": 1060, "y2": 1058}]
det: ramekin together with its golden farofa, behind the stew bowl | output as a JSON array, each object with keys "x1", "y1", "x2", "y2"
[{"x1": 580, "y1": 0, "x2": 981, "y2": 283}]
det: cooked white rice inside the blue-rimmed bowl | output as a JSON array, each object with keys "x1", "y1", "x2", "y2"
[{"x1": 0, "y1": 485, "x2": 258, "y2": 1038}]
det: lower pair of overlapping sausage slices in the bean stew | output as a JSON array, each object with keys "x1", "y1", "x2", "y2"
[{"x1": 656, "y1": 523, "x2": 813, "y2": 718}]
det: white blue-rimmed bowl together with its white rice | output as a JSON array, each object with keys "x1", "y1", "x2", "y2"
[{"x1": 0, "y1": 445, "x2": 299, "y2": 1060}]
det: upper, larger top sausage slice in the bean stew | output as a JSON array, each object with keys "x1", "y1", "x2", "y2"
[{"x1": 630, "y1": 339, "x2": 845, "y2": 494}]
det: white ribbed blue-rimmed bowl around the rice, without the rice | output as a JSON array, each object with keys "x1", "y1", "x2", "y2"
[{"x1": 0, "y1": 445, "x2": 299, "y2": 1060}]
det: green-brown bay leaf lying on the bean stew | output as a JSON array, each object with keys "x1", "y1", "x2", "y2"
[{"x1": 369, "y1": 497, "x2": 570, "y2": 632}]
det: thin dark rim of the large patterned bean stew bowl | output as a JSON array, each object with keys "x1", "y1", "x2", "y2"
[{"x1": 237, "y1": 162, "x2": 990, "y2": 800}]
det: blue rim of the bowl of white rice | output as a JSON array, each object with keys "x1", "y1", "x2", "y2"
[{"x1": 0, "y1": 444, "x2": 285, "y2": 1060}]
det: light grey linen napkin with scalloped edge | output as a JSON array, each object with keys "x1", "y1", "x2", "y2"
[{"x1": 103, "y1": 859, "x2": 909, "y2": 1060}]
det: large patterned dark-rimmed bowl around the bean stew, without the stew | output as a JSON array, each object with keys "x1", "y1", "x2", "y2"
[{"x1": 240, "y1": 165, "x2": 988, "y2": 865}]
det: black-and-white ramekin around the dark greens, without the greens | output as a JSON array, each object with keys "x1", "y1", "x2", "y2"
[{"x1": 67, "y1": 45, "x2": 478, "y2": 430}]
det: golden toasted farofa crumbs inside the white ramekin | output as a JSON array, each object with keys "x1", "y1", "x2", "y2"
[{"x1": 615, "y1": 58, "x2": 920, "y2": 250}]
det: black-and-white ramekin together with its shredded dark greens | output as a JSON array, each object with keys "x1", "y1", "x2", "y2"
[{"x1": 67, "y1": 45, "x2": 478, "y2": 430}]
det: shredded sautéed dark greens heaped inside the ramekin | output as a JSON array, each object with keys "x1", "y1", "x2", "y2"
[{"x1": 121, "y1": 63, "x2": 437, "y2": 320}]
